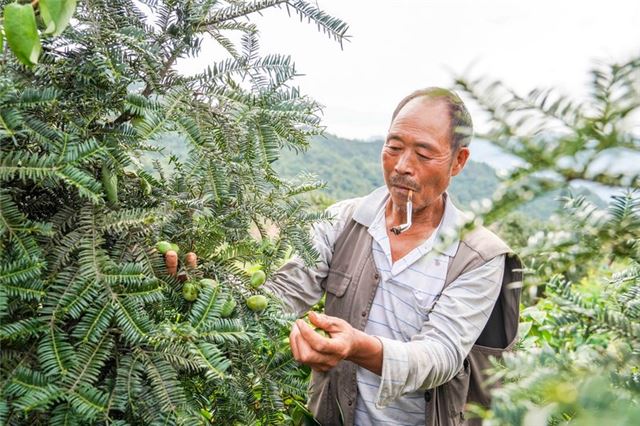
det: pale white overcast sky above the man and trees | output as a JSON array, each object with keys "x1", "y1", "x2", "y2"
[{"x1": 185, "y1": 0, "x2": 640, "y2": 139}]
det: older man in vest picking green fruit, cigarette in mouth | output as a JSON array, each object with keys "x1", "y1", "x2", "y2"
[{"x1": 266, "y1": 88, "x2": 519, "y2": 425}]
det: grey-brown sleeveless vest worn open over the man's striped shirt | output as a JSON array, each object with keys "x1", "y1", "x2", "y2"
[{"x1": 309, "y1": 216, "x2": 522, "y2": 426}]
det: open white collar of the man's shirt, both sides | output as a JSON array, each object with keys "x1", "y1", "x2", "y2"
[{"x1": 353, "y1": 186, "x2": 465, "y2": 256}]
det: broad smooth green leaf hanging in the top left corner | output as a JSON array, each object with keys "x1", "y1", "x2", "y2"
[{"x1": 4, "y1": 3, "x2": 42, "y2": 67}]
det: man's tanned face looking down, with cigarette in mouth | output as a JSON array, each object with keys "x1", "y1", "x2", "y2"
[{"x1": 382, "y1": 97, "x2": 469, "y2": 212}]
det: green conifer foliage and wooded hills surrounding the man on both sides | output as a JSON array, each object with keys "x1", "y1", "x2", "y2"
[{"x1": 0, "y1": 0, "x2": 640, "y2": 425}]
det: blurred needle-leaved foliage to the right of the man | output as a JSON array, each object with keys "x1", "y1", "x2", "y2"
[{"x1": 457, "y1": 58, "x2": 640, "y2": 425}]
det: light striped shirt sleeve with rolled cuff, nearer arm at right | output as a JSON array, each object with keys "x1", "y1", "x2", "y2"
[{"x1": 376, "y1": 255, "x2": 505, "y2": 408}]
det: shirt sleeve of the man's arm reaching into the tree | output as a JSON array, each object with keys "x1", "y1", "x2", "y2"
[{"x1": 263, "y1": 198, "x2": 358, "y2": 316}]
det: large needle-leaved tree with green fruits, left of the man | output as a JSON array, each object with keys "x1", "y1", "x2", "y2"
[{"x1": 0, "y1": 0, "x2": 346, "y2": 425}]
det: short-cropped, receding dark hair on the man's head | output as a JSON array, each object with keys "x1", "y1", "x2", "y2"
[{"x1": 391, "y1": 87, "x2": 473, "y2": 152}]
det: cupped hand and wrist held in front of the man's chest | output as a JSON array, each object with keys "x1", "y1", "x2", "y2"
[{"x1": 289, "y1": 312, "x2": 382, "y2": 374}]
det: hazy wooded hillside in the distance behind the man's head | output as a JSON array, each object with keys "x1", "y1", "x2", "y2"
[{"x1": 274, "y1": 135, "x2": 603, "y2": 219}]
